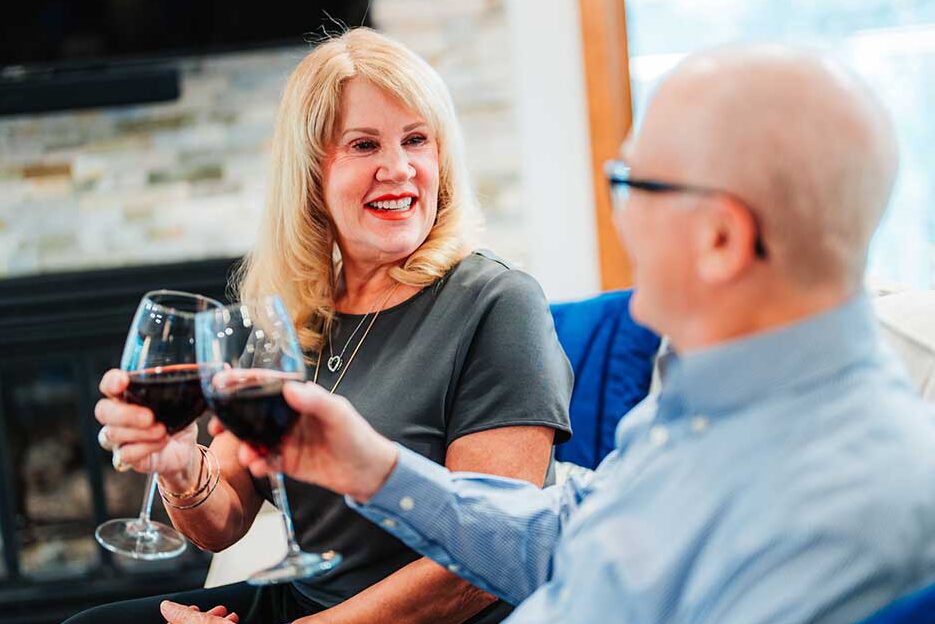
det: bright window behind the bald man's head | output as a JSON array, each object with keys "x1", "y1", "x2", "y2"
[{"x1": 627, "y1": 0, "x2": 935, "y2": 288}]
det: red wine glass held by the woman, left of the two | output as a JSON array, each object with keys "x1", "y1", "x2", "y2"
[{"x1": 94, "y1": 290, "x2": 222, "y2": 561}]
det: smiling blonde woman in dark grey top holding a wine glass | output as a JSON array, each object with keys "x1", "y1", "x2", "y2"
[{"x1": 72, "y1": 29, "x2": 572, "y2": 624}]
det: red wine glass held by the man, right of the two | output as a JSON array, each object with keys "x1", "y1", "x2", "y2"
[{"x1": 195, "y1": 295, "x2": 341, "y2": 585}]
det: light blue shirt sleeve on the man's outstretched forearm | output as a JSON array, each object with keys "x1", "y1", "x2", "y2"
[{"x1": 346, "y1": 446, "x2": 583, "y2": 604}]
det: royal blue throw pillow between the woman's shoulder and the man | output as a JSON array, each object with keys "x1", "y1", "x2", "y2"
[{"x1": 551, "y1": 290, "x2": 659, "y2": 468}]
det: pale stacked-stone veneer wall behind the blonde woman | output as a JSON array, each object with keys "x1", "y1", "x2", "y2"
[{"x1": 0, "y1": 0, "x2": 525, "y2": 277}]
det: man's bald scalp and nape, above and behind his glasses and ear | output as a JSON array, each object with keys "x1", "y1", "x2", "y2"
[{"x1": 631, "y1": 46, "x2": 897, "y2": 288}]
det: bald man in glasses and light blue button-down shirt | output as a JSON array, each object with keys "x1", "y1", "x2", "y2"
[{"x1": 164, "y1": 46, "x2": 935, "y2": 624}]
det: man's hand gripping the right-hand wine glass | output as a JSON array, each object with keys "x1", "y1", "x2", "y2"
[{"x1": 240, "y1": 382, "x2": 398, "y2": 502}]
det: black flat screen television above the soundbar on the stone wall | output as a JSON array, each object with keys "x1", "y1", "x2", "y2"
[{"x1": 0, "y1": 0, "x2": 371, "y2": 75}]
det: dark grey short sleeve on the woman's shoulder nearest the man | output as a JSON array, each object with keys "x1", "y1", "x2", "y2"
[{"x1": 446, "y1": 269, "x2": 573, "y2": 444}]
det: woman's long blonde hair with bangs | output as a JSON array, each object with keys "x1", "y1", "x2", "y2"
[{"x1": 233, "y1": 28, "x2": 479, "y2": 351}]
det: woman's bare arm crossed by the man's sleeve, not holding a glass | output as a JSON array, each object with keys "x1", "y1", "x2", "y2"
[{"x1": 296, "y1": 426, "x2": 555, "y2": 624}]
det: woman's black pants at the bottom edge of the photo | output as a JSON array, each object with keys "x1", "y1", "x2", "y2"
[{"x1": 63, "y1": 583, "x2": 324, "y2": 624}]
